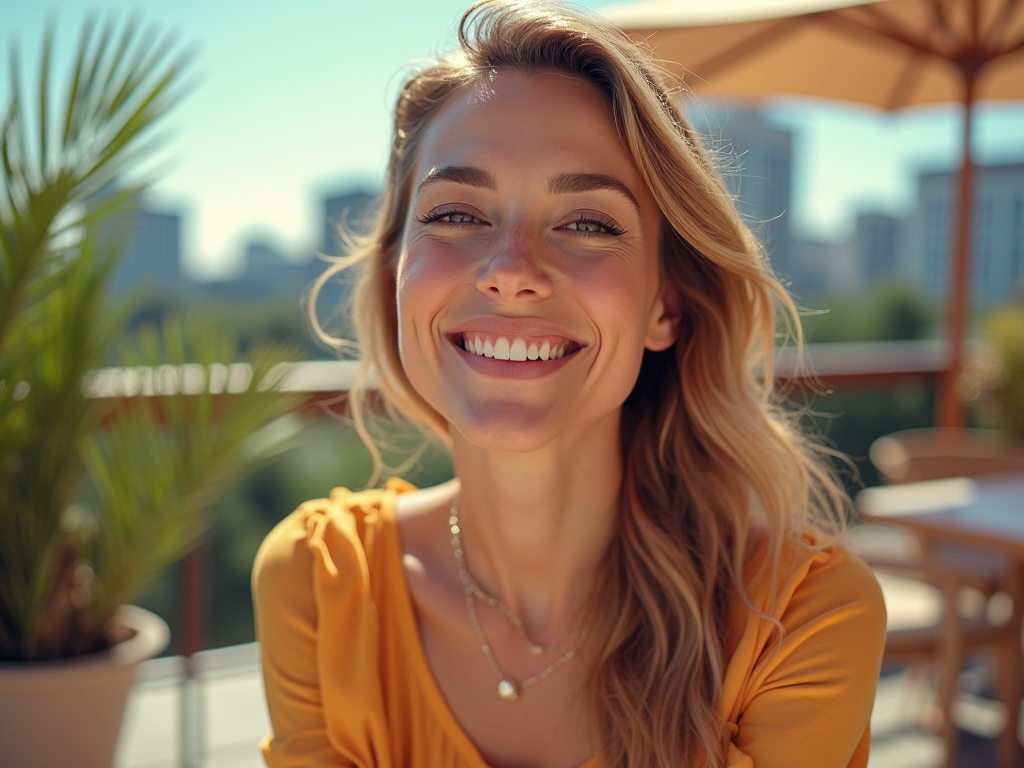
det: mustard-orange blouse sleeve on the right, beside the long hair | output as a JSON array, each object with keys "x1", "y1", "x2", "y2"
[{"x1": 723, "y1": 546, "x2": 886, "y2": 768}]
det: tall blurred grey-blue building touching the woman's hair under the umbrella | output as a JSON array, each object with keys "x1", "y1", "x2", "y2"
[{"x1": 688, "y1": 104, "x2": 790, "y2": 278}]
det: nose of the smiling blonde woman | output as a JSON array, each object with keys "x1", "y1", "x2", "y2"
[{"x1": 476, "y1": 228, "x2": 553, "y2": 301}]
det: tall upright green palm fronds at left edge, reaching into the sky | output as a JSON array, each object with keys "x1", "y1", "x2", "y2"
[{"x1": 0, "y1": 17, "x2": 198, "y2": 658}]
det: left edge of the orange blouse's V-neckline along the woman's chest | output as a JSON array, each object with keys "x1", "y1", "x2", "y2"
[{"x1": 381, "y1": 488, "x2": 600, "y2": 768}]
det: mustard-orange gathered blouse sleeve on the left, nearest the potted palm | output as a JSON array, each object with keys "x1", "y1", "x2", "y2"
[{"x1": 252, "y1": 489, "x2": 390, "y2": 768}]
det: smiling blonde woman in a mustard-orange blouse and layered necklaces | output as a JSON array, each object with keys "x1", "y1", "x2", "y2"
[{"x1": 253, "y1": 1, "x2": 885, "y2": 768}]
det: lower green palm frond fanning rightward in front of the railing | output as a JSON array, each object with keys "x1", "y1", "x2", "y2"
[{"x1": 85, "y1": 323, "x2": 295, "y2": 627}]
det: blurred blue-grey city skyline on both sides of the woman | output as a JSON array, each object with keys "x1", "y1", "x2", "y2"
[{"x1": 112, "y1": 151, "x2": 1024, "y2": 307}]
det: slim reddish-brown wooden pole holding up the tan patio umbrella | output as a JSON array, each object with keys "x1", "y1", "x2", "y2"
[{"x1": 935, "y1": 68, "x2": 978, "y2": 429}]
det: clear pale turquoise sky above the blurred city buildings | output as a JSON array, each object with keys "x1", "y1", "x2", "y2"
[{"x1": 0, "y1": 0, "x2": 1024, "y2": 275}]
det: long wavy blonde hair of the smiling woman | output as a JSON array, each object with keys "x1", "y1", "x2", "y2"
[{"x1": 309, "y1": 0, "x2": 846, "y2": 768}]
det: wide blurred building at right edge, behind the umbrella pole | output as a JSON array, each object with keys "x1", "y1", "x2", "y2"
[{"x1": 902, "y1": 163, "x2": 1024, "y2": 305}]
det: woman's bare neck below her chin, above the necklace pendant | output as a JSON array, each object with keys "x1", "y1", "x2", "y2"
[{"x1": 452, "y1": 411, "x2": 623, "y2": 643}]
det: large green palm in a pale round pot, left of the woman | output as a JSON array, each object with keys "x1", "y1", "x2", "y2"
[{"x1": 0, "y1": 23, "x2": 293, "y2": 768}]
